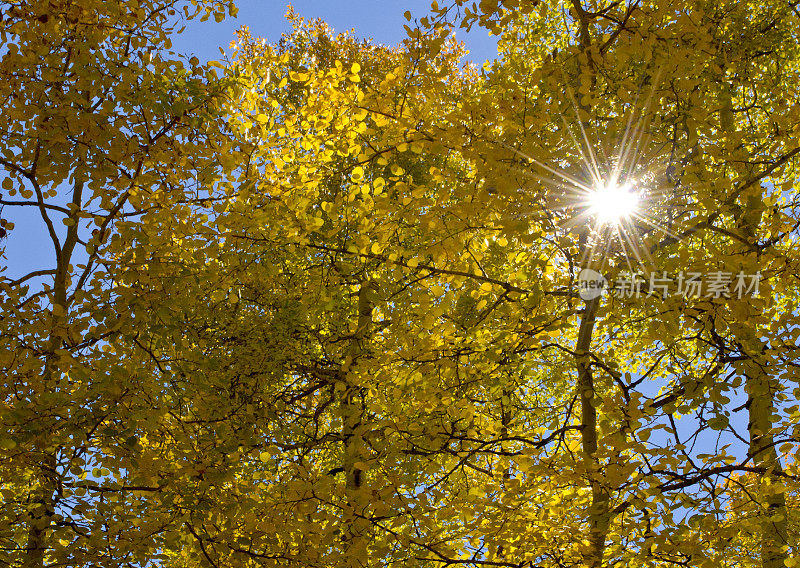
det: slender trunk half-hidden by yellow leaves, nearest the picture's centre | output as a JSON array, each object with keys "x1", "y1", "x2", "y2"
[{"x1": 340, "y1": 282, "x2": 375, "y2": 568}]
